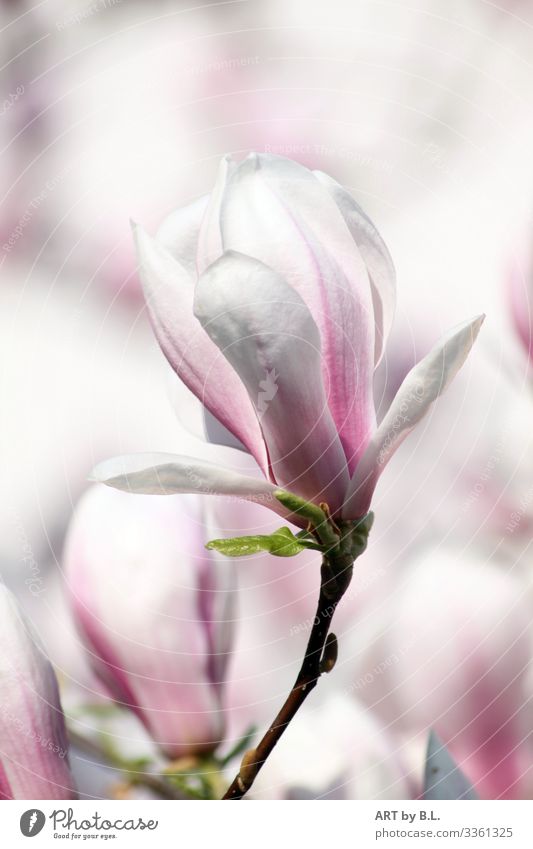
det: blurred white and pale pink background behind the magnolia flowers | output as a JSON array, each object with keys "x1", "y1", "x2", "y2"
[{"x1": 0, "y1": 0, "x2": 533, "y2": 798}]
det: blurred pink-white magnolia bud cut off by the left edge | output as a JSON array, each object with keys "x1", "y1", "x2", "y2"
[{"x1": 0, "y1": 584, "x2": 76, "y2": 799}]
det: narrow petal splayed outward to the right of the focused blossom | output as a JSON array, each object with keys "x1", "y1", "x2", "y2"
[{"x1": 342, "y1": 315, "x2": 485, "y2": 519}]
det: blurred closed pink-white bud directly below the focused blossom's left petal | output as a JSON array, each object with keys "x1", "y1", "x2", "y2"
[{"x1": 65, "y1": 487, "x2": 235, "y2": 757}]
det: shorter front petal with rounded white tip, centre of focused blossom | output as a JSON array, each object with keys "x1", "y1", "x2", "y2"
[{"x1": 191, "y1": 251, "x2": 348, "y2": 511}]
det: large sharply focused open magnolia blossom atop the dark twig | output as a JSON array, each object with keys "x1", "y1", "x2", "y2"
[{"x1": 95, "y1": 154, "x2": 483, "y2": 519}]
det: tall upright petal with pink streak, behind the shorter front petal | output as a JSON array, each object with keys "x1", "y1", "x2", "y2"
[{"x1": 216, "y1": 155, "x2": 375, "y2": 471}]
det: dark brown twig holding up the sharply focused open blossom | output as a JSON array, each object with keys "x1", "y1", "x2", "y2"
[{"x1": 223, "y1": 554, "x2": 353, "y2": 799}]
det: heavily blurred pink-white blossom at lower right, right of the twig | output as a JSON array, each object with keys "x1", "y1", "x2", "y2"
[{"x1": 354, "y1": 550, "x2": 533, "y2": 799}]
